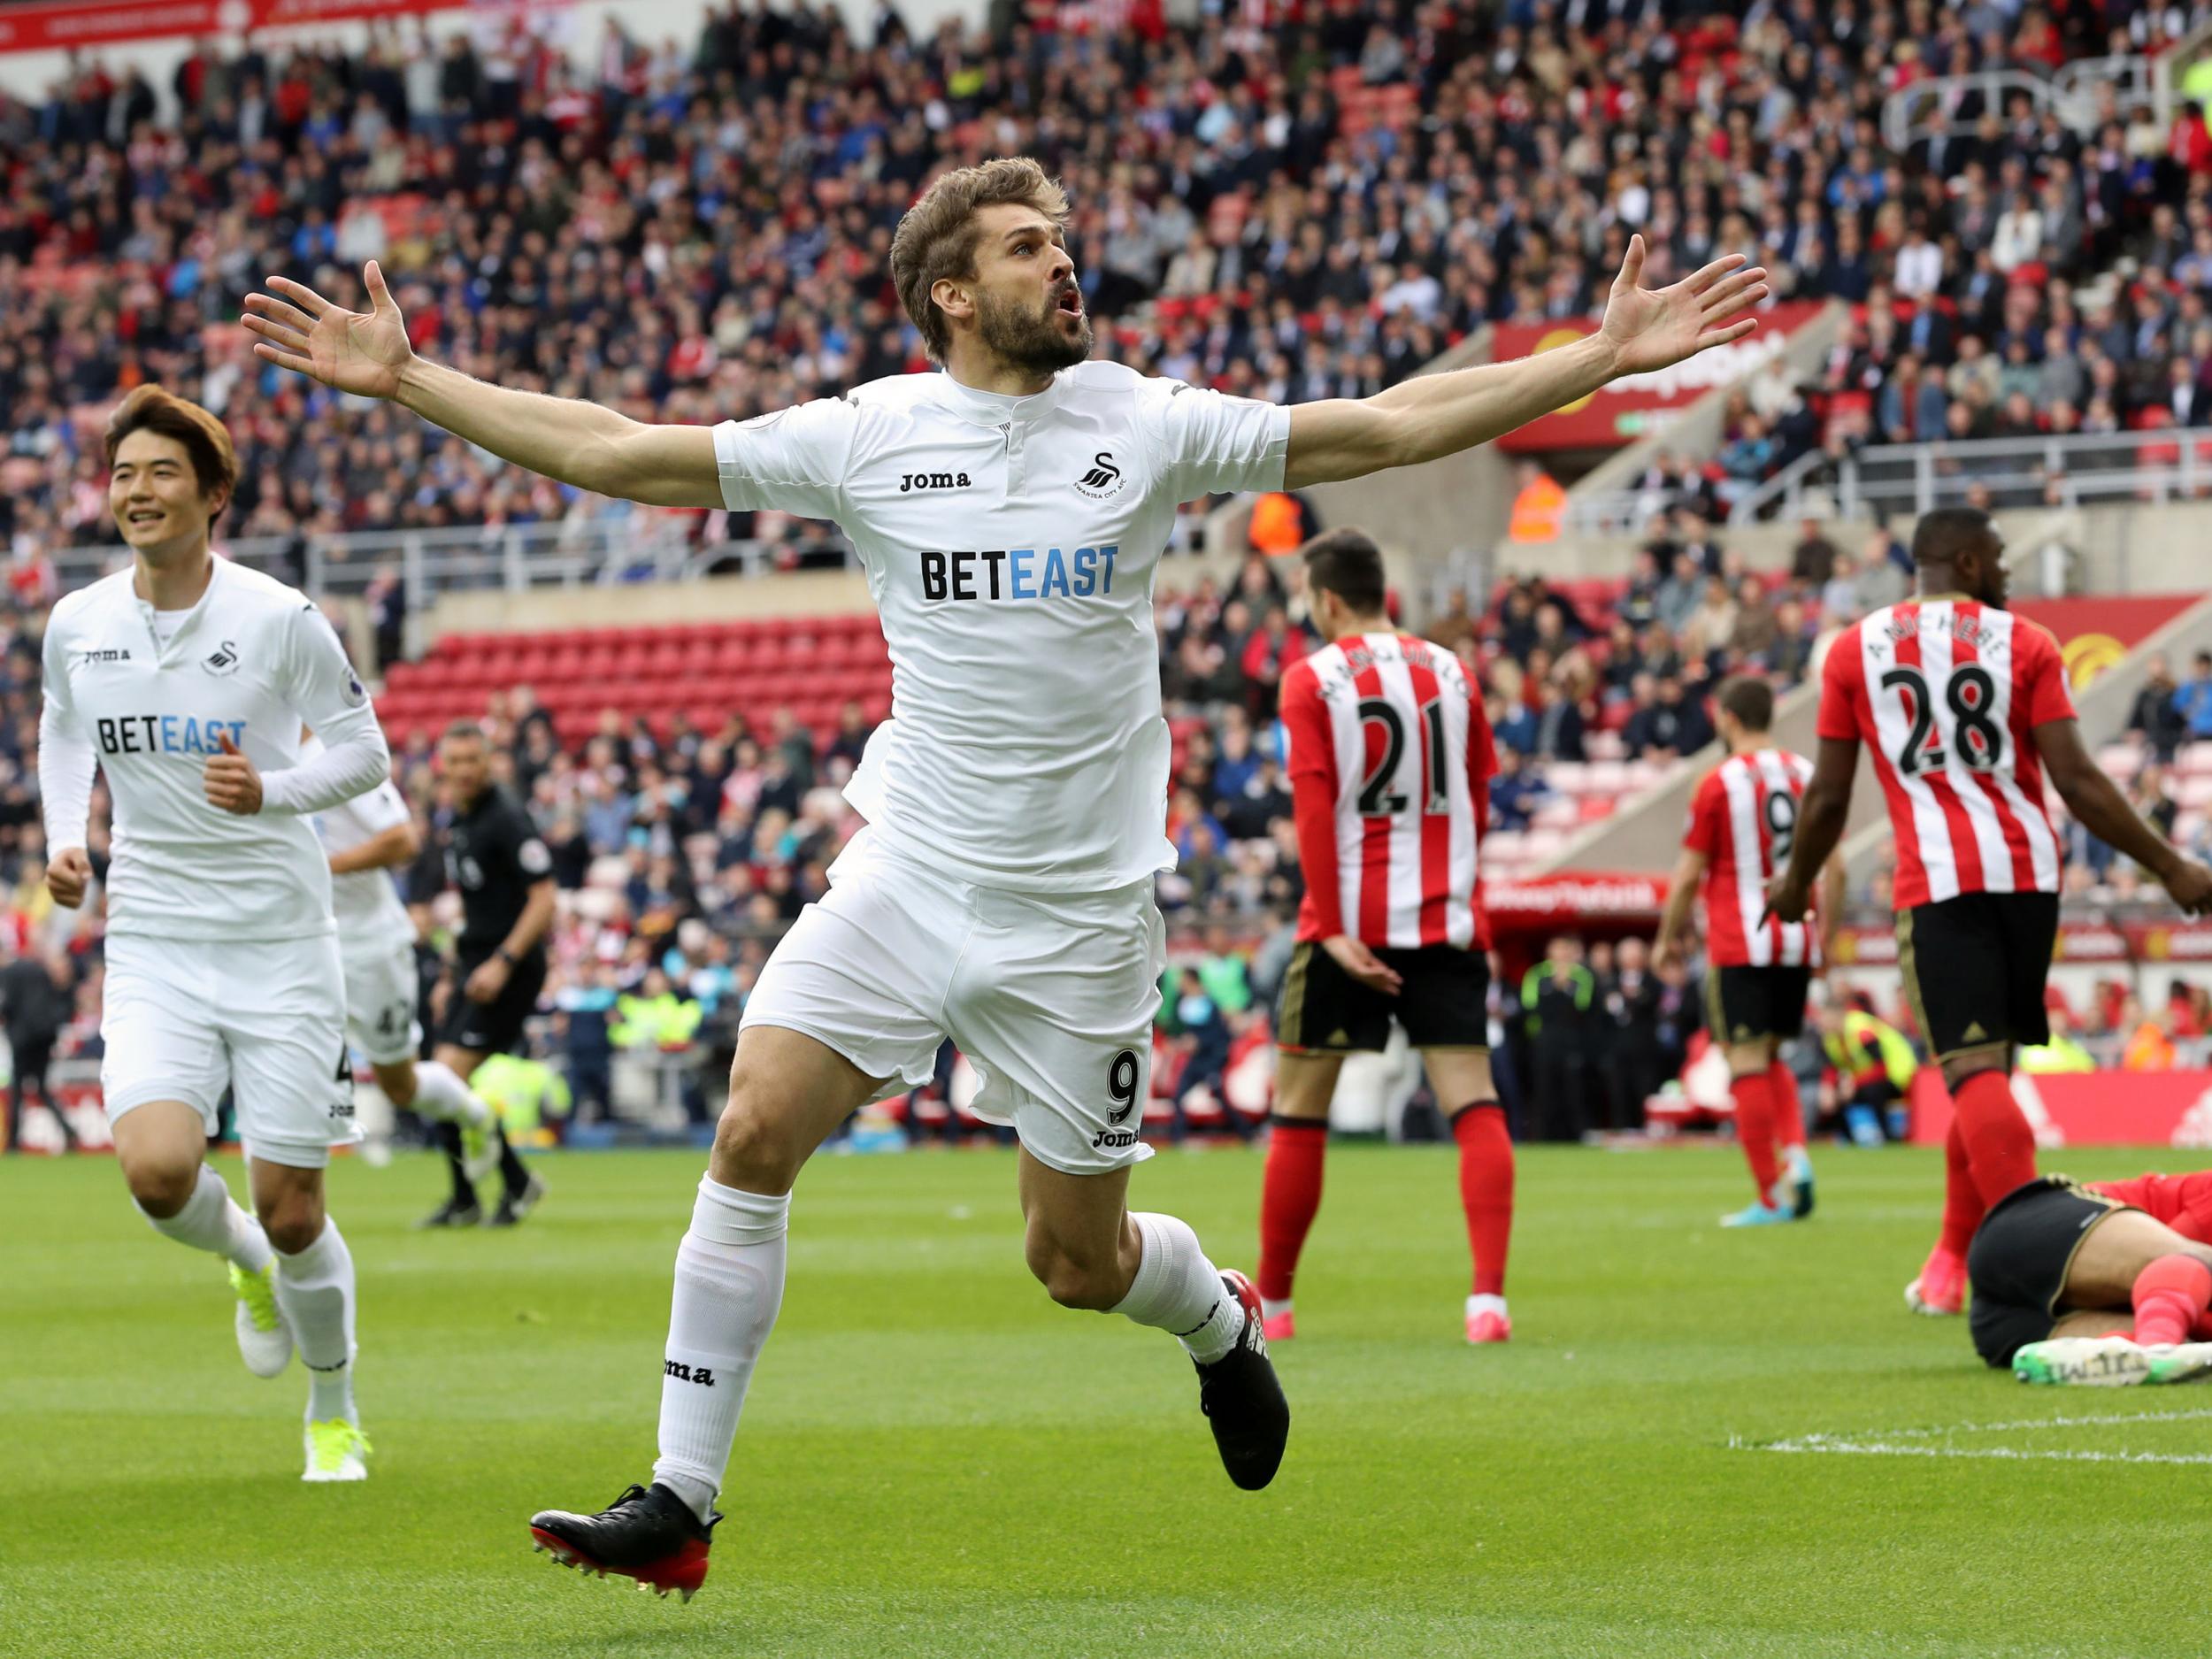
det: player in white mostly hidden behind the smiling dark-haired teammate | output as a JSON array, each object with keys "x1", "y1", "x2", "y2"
[{"x1": 310, "y1": 739, "x2": 500, "y2": 1181}]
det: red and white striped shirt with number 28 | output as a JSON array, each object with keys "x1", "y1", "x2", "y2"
[{"x1": 1821, "y1": 597, "x2": 2075, "y2": 910}]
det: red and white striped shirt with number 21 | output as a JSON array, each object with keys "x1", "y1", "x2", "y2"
[{"x1": 1283, "y1": 633, "x2": 1498, "y2": 949}]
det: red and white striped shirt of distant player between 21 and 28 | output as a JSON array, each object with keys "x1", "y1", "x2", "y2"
[{"x1": 1681, "y1": 748, "x2": 1821, "y2": 967}]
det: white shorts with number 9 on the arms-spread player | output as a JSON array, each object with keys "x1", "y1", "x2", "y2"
[{"x1": 743, "y1": 830, "x2": 1166, "y2": 1175}]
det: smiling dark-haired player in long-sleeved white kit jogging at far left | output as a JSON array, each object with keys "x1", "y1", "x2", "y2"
[{"x1": 38, "y1": 385, "x2": 392, "y2": 1480}]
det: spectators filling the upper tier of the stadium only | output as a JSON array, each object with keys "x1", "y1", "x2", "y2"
[{"x1": 0, "y1": 0, "x2": 2212, "y2": 562}]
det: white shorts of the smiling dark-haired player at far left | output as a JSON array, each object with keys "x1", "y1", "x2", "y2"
[{"x1": 100, "y1": 933, "x2": 358, "y2": 1171}]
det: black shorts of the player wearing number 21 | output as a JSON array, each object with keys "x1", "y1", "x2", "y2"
[{"x1": 1274, "y1": 941, "x2": 1491, "y2": 1056}]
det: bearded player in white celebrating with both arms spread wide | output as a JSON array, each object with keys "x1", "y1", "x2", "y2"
[{"x1": 246, "y1": 159, "x2": 1768, "y2": 1593}]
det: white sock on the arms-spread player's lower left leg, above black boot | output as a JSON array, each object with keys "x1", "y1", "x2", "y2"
[{"x1": 653, "y1": 1175, "x2": 792, "y2": 1520}]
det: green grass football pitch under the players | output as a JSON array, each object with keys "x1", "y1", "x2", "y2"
[{"x1": 0, "y1": 1146, "x2": 2212, "y2": 1659}]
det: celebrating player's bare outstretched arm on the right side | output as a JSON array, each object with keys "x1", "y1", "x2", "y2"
[{"x1": 1283, "y1": 237, "x2": 1768, "y2": 489}]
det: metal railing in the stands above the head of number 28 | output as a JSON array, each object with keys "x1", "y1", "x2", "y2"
[{"x1": 1728, "y1": 427, "x2": 2212, "y2": 525}]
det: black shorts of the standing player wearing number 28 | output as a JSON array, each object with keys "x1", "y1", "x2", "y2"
[{"x1": 1898, "y1": 894, "x2": 2060, "y2": 1060}]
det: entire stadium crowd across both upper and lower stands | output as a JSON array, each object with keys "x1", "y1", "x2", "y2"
[{"x1": 0, "y1": 0, "x2": 2212, "y2": 1141}]
